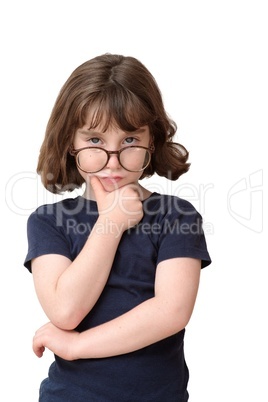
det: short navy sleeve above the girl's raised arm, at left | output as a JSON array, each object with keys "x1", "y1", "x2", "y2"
[{"x1": 24, "y1": 207, "x2": 71, "y2": 272}]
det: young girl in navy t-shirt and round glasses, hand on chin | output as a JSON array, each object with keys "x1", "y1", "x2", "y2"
[{"x1": 25, "y1": 54, "x2": 210, "y2": 402}]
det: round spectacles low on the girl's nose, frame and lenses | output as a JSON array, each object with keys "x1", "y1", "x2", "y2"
[{"x1": 70, "y1": 146, "x2": 153, "y2": 173}]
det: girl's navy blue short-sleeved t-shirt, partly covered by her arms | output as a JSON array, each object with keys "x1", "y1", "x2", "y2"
[{"x1": 24, "y1": 193, "x2": 211, "y2": 402}]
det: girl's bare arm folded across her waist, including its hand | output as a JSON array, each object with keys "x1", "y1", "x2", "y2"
[{"x1": 33, "y1": 258, "x2": 201, "y2": 360}]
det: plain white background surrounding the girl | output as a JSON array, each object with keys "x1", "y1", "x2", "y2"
[{"x1": 0, "y1": 0, "x2": 268, "y2": 402}]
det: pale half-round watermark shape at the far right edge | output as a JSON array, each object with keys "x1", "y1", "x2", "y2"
[{"x1": 227, "y1": 169, "x2": 263, "y2": 233}]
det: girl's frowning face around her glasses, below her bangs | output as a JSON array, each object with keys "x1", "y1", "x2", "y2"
[{"x1": 73, "y1": 118, "x2": 151, "y2": 196}]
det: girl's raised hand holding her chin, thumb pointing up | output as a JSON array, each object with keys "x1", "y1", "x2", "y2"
[{"x1": 90, "y1": 176, "x2": 143, "y2": 232}]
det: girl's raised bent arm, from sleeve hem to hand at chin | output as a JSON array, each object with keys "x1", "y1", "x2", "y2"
[{"x1": 32, "y1": 177, "x2": 143, "y2": 330}]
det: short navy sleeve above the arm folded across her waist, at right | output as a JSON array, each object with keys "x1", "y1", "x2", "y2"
[{"x1": 157, "y1": 201, "x2": 211, "y2": 268}]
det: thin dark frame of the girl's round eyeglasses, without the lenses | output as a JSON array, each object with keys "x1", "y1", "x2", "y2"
[{"x1": 69, "y1": 144, "x2": 155, "y2": 173}]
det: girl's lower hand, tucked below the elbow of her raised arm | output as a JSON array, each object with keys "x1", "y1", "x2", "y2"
[{"x1": 33, "y1": 322, "x2": 79, "y2": 360}]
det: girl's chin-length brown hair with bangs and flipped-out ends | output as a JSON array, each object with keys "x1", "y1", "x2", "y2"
[{"x1": 37, "y1": 54, "x2": 190, "y2": 193}]
